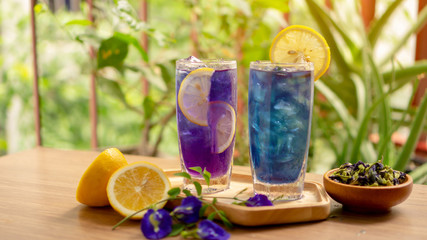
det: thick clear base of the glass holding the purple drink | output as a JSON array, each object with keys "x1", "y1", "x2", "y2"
[{"x1": 184, "y1": 174, "x2": 230, "y2": 194}]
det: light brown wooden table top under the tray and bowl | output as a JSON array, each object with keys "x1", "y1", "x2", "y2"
[{"x1": 0, "y1": 148, "x2": 427, "y2": 240}]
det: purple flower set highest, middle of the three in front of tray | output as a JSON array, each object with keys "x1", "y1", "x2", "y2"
[{"x1": 172, "y1": 196, "x2": 202, "y2": 223}]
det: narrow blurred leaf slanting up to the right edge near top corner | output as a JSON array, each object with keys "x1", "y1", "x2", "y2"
[{"x1": 380, "y1": 6, "x2": 427, "y2": 66}]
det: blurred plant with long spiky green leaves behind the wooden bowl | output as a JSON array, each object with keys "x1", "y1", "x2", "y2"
[{"x1": 306, "y1": 0, "x2": 427, "y2": 184}]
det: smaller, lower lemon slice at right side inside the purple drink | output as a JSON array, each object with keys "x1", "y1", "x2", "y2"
[{"x1": 208, "y1": 101, "x2": 236, "y2": 153}]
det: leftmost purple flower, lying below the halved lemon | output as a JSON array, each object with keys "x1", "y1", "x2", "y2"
[{"x1": 141, "y1": 209, "x2": 172, "y2": 239}]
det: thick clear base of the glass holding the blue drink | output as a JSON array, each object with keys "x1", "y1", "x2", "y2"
[{"x1": 254, "y1": 181, "x2": 304, "y2": 201}]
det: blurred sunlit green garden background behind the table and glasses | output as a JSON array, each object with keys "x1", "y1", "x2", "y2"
[{"x1": 0, "y1": 0, "x2": 427, "y2": 183}]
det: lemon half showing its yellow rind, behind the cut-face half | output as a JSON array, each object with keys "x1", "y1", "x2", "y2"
[{"x1": 76, "y1": 148, "x2": 128, "y2": 207}]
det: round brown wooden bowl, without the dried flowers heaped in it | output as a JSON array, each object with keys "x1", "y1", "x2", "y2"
[{"x1": 323, "y1": 168, "x2": 413, "y2": 213}]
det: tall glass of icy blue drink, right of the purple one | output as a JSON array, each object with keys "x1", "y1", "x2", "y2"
[{"x1": 249, "y1": 61, "x2": 314, "y2": 200}]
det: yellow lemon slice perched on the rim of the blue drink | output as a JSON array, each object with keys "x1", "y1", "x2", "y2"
[{"x1": 270, "y1": 25, "x2": 331, "y2": 80}]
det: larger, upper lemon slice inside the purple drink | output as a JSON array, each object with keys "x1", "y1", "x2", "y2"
[{"x1": 178, "y1": 68, "x2": 215, "y2": 126}]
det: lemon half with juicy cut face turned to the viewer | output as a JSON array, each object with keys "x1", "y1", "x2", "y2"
[{"x1": 107, "y1": 161, "x2": 171, "y2": 219}]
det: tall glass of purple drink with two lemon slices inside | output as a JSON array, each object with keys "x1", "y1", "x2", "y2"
[{"x1": 176, "y1": 57, "x2": 237, "y2": 193}]
